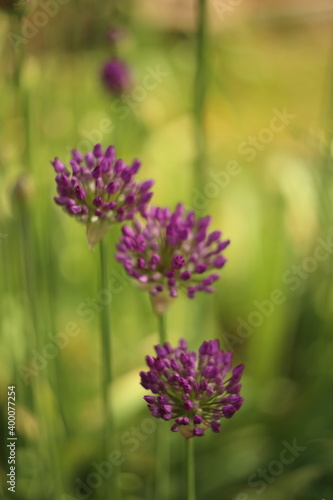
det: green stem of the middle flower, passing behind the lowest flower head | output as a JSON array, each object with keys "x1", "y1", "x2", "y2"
[{"x1": 155, "y1": 316, "x2": 170, "y2": 500}]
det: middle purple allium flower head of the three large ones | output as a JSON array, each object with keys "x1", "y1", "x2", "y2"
[{"x1": 116, "y1": 202, "x2": 230, "y2": 314}]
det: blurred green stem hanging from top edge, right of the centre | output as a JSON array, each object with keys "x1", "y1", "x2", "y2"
[{"x1": 194, "y1": 0, "x2": 207, "y2": 188}]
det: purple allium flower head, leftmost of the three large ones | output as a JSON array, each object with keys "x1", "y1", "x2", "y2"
[{"x1": 51, "y1": 144, "x2": 154, "y2": 248}]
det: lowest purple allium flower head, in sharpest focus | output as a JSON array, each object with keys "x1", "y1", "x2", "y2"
[{"x1": 140, "y1": 339, "x2": 244, "y2": 439}]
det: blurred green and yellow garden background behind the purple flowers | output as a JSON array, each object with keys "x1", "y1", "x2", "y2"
[{"x1": 0, "y1": 0, "x2": 333, "y2": 500}]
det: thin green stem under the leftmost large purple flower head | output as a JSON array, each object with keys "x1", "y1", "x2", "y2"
[{"x1": 99, "y1": 239, "x2": 116, "y2": 500}]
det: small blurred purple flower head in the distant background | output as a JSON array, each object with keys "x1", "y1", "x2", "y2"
[{"x1": 101, "y1": 58, "x2": 131, "y2": 94}]
